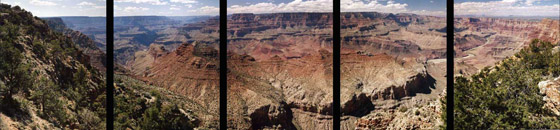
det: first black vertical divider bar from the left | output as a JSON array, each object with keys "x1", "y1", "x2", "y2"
[{"x1": 105, "y1": 0, "x2": 115, "y2": 130}]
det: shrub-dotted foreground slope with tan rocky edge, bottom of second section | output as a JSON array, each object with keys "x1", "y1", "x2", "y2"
[{"x1": 114, "y1": 75, "x2": 212, "y2": 130}]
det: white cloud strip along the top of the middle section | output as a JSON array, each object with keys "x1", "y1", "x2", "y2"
[{"x1": 227, "y1": 0, "x2": 333, "y2": 13}]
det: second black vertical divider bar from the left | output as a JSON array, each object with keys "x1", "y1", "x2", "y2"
[{"x1": 220, "y1": 0, "x2": 227, "y2": 130}]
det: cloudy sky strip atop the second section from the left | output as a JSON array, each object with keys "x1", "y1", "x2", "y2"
[{"x1": 114, "y1": 0, "x2": 220, "y2": 16}]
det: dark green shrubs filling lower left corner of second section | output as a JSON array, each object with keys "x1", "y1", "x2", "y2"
[{"x1": 115, "y1": 76, "x2": 195, "y2": 130}]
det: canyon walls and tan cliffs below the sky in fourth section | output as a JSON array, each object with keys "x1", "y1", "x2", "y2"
[{"x1": 341, "y1": 12, "x2": 447, "y2": 129}]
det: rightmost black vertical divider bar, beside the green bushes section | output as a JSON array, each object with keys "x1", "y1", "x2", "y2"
[{"x1": 446, "y1": 0, "x2": 455, "y2": 130}]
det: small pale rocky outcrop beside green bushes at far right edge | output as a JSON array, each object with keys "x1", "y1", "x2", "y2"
[{"x1": 539, "y1": 77, "x2": 560, "y2": 116}]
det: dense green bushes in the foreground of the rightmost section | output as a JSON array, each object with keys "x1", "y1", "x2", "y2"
[{"x1": 452, "y1": 39, "x2": 560, "y2": 129}]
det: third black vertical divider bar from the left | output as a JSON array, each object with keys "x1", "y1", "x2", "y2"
[{"x1": 333, "y1": 0, "x2": 341, "y2": 130}]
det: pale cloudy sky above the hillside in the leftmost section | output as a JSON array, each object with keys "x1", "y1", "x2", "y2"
[{"x1": 1, "y1": 0, "x2": 106, "y2": 17}]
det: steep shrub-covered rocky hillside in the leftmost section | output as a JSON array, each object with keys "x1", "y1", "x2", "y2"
[{"x1": 0, "y1": 4, "x2": 105, "y2": 129}]
